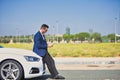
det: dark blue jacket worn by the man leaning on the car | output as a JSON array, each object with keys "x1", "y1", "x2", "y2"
[{"x1": 33, "y1": 31, "x2": 48, "y2": 57}]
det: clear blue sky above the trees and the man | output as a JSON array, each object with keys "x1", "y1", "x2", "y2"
[{"x1": 0, "y1": 0, "x2": 120, "y2": 36}]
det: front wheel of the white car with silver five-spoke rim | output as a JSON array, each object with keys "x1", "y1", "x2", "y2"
[{"x1": 0, "y1": 60, "x2": 23, "y2": 80}]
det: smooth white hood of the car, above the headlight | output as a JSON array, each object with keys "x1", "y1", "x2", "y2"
[{"x1": 0, "y1": 48, "x2": 40, "y2": 57}]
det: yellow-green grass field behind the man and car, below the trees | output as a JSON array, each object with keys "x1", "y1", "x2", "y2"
[{"x1": 0, "y1": 43, "x2": 120, "y2": 57}]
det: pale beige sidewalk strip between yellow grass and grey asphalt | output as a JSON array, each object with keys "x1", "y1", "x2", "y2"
[{"x1": 54, "y1": 57, "x2": 120, "y2": 70}]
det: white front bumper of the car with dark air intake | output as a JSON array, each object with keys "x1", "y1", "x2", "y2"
[{"x1": 23, "y1": 60, "x2": 43, "y2": 78}]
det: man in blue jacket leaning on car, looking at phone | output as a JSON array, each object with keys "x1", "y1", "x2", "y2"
[{"x1": 33, "y1": 24, "x2": 65, "y2": 79}]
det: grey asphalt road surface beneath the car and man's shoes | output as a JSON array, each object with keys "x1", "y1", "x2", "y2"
[{"x1": 26, "y1": 70, "x2": 120, "y2": 80}]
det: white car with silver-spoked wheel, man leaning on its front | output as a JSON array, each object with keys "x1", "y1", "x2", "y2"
[{"x1": 0, "y1": 48, "x2": 44, "y2": 80}]
